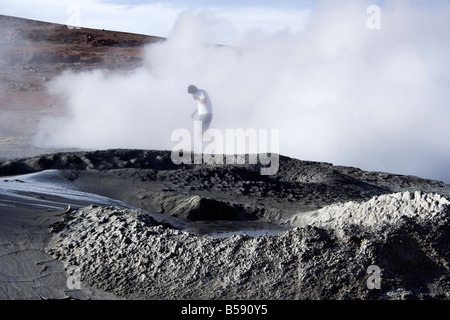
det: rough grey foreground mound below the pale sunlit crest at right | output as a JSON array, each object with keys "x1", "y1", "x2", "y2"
[{"x1": 47, "y1": 195, "x2": 450, "y2": 299}]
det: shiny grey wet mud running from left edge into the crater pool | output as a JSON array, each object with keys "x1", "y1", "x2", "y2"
[{"x1": 0, "y1": 170, "x2": 289, "y2": 238}]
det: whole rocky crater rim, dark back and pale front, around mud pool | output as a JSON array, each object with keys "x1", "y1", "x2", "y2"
[{"x1": 0, "y1": 150, "x2": 450, "y2": 299}]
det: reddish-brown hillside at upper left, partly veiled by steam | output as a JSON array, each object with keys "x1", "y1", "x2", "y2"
[{"x1": 0, "y1": 15, "x2": 163, "y2": 137}]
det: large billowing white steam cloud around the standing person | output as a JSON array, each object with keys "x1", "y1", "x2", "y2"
[{"x1": 36, "y1": 0, "x2": 450, "y2": 182}]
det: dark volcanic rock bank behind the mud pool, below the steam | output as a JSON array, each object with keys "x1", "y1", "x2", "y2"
[{"x1": 0, "y1": 149, "x2": 450, "y2": 222}]
